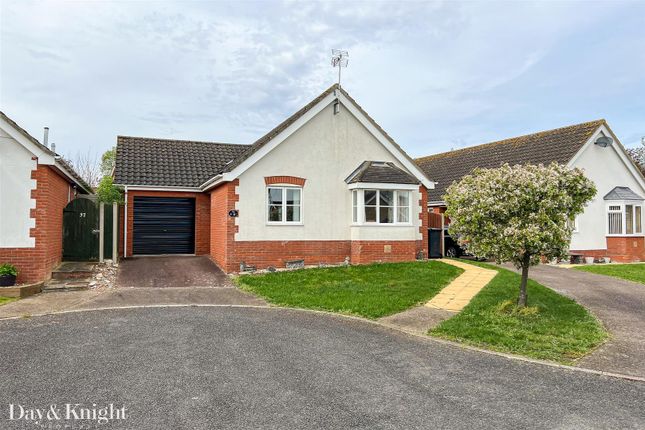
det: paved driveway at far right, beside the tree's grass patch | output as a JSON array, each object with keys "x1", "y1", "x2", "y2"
[{"x1": 512, "y1": 265, "x2": 645, "y2": 377}]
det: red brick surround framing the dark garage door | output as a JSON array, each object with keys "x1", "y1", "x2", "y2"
[{"x1": 119, "y1": 190, "x2": 211, "y2": 257}]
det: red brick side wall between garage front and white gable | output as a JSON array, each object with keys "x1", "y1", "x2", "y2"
[{"x1": 209, "y1": 179, "x2": 239, "y2": 272}]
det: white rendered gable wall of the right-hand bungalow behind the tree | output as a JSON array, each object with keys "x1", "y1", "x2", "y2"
[{"x1": 570, "y1": 129, "x2": 645, "y2": 250}]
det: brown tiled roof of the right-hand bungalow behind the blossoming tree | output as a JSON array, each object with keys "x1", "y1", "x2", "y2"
[{"x1": 416, "y1": 119, "x2": 606, "y2": 202}]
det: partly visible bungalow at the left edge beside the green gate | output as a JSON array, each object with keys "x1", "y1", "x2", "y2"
[{"x1": 0, "y1": 112, "x2": 92, "y2": 283}]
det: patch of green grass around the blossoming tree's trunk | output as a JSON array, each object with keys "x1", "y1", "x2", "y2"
[{"x1": 429, "y1": 262, "x2": 608, "y2": 363}]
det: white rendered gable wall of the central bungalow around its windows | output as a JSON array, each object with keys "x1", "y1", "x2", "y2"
[{"x1": 235, "y1": 101, "x2": 421, "y2": 241}]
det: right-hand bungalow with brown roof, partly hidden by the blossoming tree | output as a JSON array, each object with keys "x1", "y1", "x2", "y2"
[{"x1": 416, "y1": 119, "x2": 645, "y2": 262}]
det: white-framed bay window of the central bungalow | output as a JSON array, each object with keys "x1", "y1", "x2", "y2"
[{"x1": 352, "y1": 189, "x2": 412, "y2": 225}]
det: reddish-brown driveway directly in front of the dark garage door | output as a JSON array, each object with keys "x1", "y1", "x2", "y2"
[{"x1": 117, "y1": 256, "x2": 232, "y2": 288}]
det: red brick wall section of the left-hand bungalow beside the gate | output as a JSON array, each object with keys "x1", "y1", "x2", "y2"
[{"x1": 0, "y1": 165, "x2": 73, "y2": 283}]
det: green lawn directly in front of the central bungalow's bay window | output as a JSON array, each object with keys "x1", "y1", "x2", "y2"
[{"x1": 237, "y1": 261, "x2": 462, "y2": 319}]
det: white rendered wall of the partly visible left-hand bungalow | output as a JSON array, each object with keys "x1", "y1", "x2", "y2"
[{"x1": 0, "y1": 129, "x2": 37, "y2": 248}]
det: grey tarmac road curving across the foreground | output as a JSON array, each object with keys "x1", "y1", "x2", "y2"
[{"x1": 0, "y1": 307, "x2": 645, "y2": 429}]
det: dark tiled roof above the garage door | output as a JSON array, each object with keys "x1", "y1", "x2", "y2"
[{"x1": 114, "y1": 136, "x2": 250, "y2": 187}]
